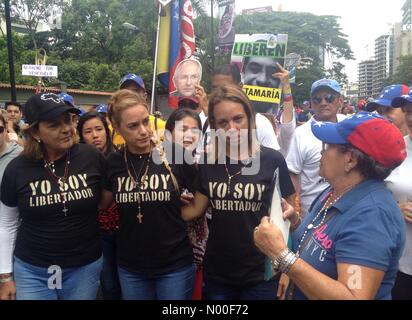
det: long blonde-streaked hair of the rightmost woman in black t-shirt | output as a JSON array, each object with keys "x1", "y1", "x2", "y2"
[{"x1": 208, "y1": 84, "x2": 260, "y2": 160}]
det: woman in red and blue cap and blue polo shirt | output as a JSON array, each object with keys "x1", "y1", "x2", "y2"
[{"x1": 254, "y1": 112, "x2": 406, "y2": 299}]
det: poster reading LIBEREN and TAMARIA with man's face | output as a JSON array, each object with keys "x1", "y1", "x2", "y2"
[{"x1": 231, "y1": 34, "x2": 288, "y2": 114}]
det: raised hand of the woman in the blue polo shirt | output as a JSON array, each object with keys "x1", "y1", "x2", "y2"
[{"x1": 253, "y1": 217, "x2": 287, "y2": 259}]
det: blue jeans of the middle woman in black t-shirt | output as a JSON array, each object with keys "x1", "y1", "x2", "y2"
[{"x1": 119, "y1": 265, "x2": 195, "y2": 300}]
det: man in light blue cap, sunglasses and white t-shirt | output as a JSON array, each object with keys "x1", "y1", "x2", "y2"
[{"x1": 286, "y1": 79, "x2": 345, "y2": 216}]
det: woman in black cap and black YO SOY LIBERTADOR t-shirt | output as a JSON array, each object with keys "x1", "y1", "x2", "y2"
[{"x1": 0, "y1": 93, "x2": 105, "y2": 300}]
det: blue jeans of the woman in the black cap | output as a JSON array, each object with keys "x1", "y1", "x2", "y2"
[{"x1": 14, "y1": 257, "x2": 103, "y2": 300}]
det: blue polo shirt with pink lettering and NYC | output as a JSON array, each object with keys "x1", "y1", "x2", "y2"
[{"x1": 293, "y1": 180, "x2": 405, "y2": 299}]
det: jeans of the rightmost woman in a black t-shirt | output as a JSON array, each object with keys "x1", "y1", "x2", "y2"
[{"x1": 204, "y1": 278, "x2": 279, "y2": 300}]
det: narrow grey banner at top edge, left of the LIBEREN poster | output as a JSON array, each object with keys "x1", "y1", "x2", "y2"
[{"x1": 217, "y1": 0, "x2": 236, "y2": 52}]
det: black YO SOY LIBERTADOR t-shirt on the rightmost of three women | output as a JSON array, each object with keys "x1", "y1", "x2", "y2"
[{"x1": 198, "y1": 146, "x2": 295, "y2": 287}]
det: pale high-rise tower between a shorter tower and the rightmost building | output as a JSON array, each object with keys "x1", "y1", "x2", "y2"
[{"x1": 372, "y1": 35, "x2": 393, "y2": 98}]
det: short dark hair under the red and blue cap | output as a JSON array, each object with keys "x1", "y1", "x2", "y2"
[{"x1": 338, "y1": 144, "x2": 399, "y2": 181}]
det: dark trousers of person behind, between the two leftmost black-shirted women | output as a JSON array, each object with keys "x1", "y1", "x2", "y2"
[{"x1": 100, "y1": 232, "x2": 122, "y2": 300}]
